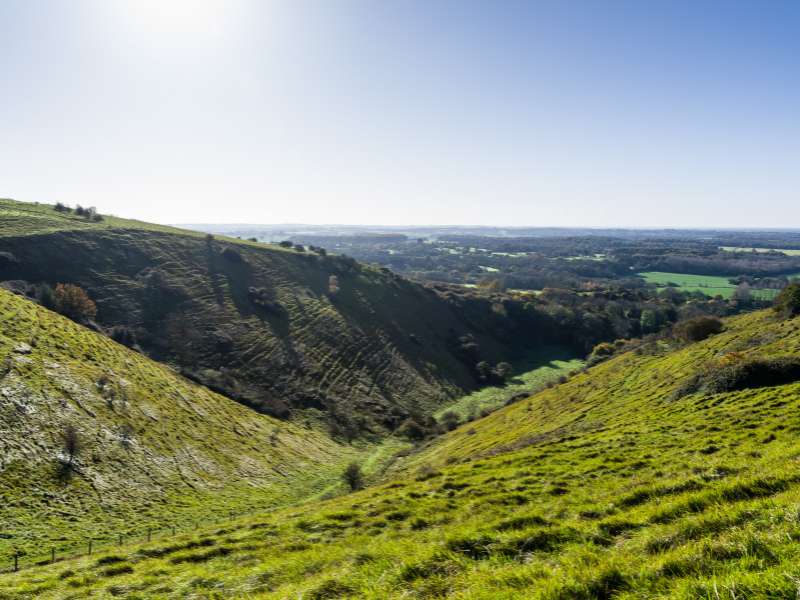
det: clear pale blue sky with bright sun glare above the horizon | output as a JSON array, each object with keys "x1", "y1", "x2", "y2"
[{"x1": 0, "y1": 0, "x2": 800, "y2": 227}]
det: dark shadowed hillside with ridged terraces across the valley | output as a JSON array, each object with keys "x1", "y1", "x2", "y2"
[{"x1": 0, "y1": 201, "x2": 538, "y2": 431}]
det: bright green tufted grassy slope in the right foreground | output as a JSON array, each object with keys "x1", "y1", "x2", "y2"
[{"x1": 6, "y1": 313, "x2": 800, "y2": 600}]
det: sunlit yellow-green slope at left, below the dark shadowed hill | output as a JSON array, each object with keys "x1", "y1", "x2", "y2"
[{"x1": 0, "y1": 290, "x2": 356, "y2": 567}]
